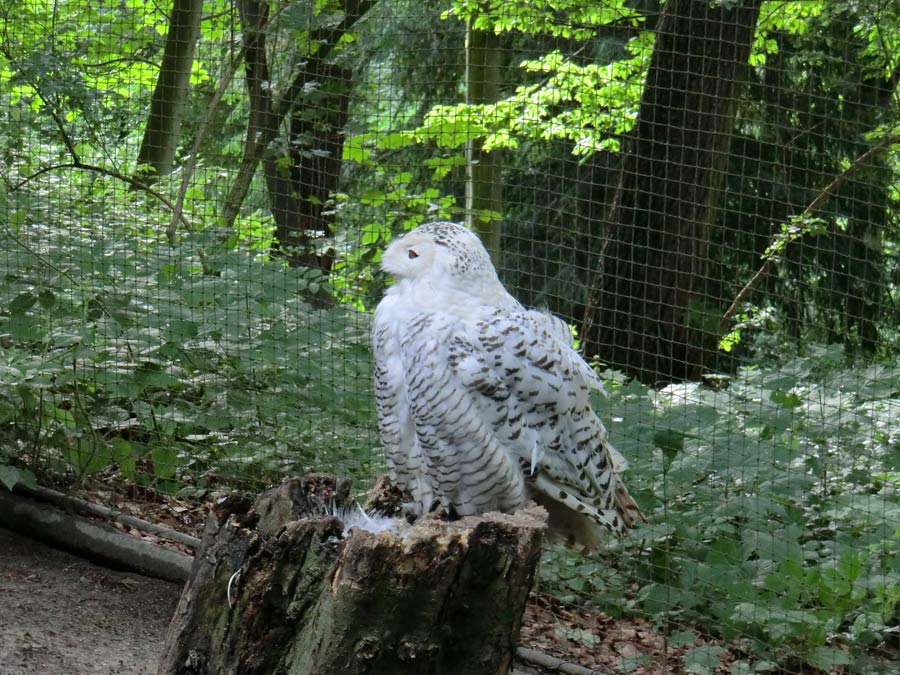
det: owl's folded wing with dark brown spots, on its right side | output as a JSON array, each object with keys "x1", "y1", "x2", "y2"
[{"x1": 474, "y1": 310, "x2": 642, "y2": 532}]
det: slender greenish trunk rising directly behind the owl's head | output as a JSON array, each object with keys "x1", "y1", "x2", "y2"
[{"x1": 466, "y1": 21, "x2": 503, "y2": 265}]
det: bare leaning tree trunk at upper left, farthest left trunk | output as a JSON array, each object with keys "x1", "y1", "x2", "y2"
[{"x1": 137, "y1": 0, "x2": 203, "y2": 183}]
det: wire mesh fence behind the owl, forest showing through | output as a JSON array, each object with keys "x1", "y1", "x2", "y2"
[{"x1": 0, "y1": 0, "x2": 900, "y2": 673}]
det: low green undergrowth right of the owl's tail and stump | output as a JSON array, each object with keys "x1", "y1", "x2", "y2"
[{"x1": 543, "y1": 347, "x2": 900, "y2": 673}]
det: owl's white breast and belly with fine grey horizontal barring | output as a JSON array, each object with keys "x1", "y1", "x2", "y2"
[{"x1": 373, "y1": 306, "x2": 525, "y2": 515}]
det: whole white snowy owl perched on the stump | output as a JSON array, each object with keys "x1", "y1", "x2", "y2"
[{"x1": 373, "y1": 222, "x2": 642, "y2": 549}]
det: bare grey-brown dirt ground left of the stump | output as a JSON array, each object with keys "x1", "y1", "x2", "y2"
[{"x1": 0, "y1": 529, "x2": 181, "y2": 675}]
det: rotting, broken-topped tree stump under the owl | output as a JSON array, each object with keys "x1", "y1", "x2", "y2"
[{"x1": 159, "y1": 475, "x2": 546, "y2": 675}]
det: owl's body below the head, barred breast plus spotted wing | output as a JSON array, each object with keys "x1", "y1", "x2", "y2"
[{"x1": 374, "y1": 306, "x2": 640, "y2": 543}]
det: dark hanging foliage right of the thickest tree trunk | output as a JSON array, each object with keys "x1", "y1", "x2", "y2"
[{"x1": 709, "y1": 2, "x2": 900, "y2": 358}]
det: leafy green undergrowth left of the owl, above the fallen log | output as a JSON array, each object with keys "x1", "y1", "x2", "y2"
[{"x1": 0, "y1": 223, "x2": 374, "y2": 492}]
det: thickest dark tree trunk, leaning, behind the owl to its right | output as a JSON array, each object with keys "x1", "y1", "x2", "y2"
[{"x1": 582, "y1": 0, "x2": 761, "y2": 384}]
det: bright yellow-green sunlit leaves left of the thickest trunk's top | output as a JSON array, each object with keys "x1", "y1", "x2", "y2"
[{"x1": 351, "y1": 0, "x2": 653, "y2": 159}]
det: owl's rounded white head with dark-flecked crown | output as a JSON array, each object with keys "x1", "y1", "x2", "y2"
[{"x1": 381, "y1": 222, "x2": 497, "y2": 281}]
